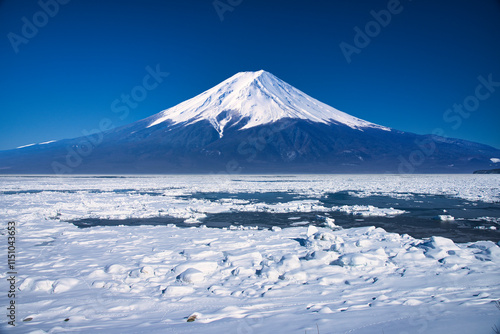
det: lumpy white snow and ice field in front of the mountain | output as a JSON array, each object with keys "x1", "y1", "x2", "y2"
[{"x1": 0, "y1": 175, "x2": 500, "y2": 334}]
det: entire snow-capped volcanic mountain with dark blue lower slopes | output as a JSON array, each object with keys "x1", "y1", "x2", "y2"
[{"x1": 0, "y1": 70, "x2": 500, "y2": 174}]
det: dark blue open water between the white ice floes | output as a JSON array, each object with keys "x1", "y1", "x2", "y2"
[{"x1": 67, "y1": 191, "x2": 500, "y2": 242}]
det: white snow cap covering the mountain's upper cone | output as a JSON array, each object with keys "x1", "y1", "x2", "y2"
[{"x1": 148, "y1": 70, "x2": 390, "y2": 137}]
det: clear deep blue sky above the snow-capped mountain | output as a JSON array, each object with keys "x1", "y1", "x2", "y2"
[{"x1": 0, "y1": 0, "x2": 500, "y2": 149}]
